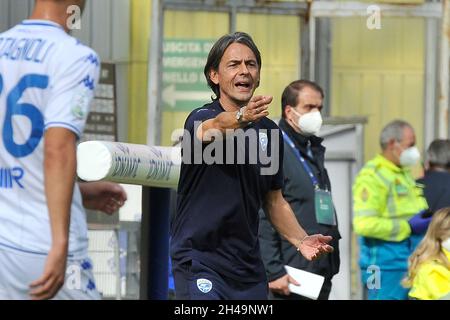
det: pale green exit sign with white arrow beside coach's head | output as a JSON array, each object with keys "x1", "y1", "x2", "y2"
[{"x1": 162, "y1": 39, "x2": 214, "y2": 111}]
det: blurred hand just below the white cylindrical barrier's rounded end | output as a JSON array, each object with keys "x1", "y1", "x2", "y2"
[{"x1": 79, "y1": 181, "x2": 127, "y2": 215}]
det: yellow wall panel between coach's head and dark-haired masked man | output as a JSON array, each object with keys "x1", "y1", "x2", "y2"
[{"x1": 236, "y1": 14, "x2": 300, "y2": 118}]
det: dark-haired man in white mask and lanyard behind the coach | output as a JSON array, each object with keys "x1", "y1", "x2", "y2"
[{"x1": 259, "y1": 80, "x2": 341, "y2": 300}]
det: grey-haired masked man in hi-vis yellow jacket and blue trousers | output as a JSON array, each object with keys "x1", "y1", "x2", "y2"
[{"x1": 353, "y1": 120, "x2": 431, "y2": 300}]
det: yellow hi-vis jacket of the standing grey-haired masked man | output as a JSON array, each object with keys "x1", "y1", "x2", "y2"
[{"x1": 353, "y1": 155, "x2": 428, "y2": 242}]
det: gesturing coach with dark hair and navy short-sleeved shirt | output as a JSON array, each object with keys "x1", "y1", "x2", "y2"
[{"x1": 171, "y1": 32, "x2": 333, "y2": 300}]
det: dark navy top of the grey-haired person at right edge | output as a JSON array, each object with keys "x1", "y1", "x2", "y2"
[{"x1": 417, "y1": 171, "x2": 450, "y2": 212}]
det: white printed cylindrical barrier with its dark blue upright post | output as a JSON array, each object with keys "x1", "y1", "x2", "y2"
[{"x1": 77, "y1": 141, "x2": 181, "y2": 300}]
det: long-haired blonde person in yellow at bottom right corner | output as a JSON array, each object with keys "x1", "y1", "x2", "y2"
[{"x1": 403, "y1": 207, "x2": 450, "y2": 300}]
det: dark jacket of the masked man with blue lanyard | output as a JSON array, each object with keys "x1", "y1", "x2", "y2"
[{"x1": 259, "y1": 119, "x2": 341, "y2": 282}]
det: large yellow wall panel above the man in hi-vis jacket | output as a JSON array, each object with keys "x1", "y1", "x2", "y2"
[{"x1": 331, "y1": 18, "x2": 425, "y2": 168}]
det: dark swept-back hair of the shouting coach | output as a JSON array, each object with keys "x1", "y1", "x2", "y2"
[{"x1": 204, "y1": 32, "x2": 261, "y2": 99}]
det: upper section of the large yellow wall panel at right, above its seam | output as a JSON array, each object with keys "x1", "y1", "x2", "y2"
[{"x1": 333, "y1": 18, "x2": 424, "y2": 71}]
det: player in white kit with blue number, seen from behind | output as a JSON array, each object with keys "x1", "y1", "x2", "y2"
[{"x1": 0, "y1": 0, "x2": 126, "y2": 299}]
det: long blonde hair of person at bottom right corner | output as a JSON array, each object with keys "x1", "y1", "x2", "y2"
[{"x1": 402, "y1": 207, "x2": 450, "y2": 288}]
